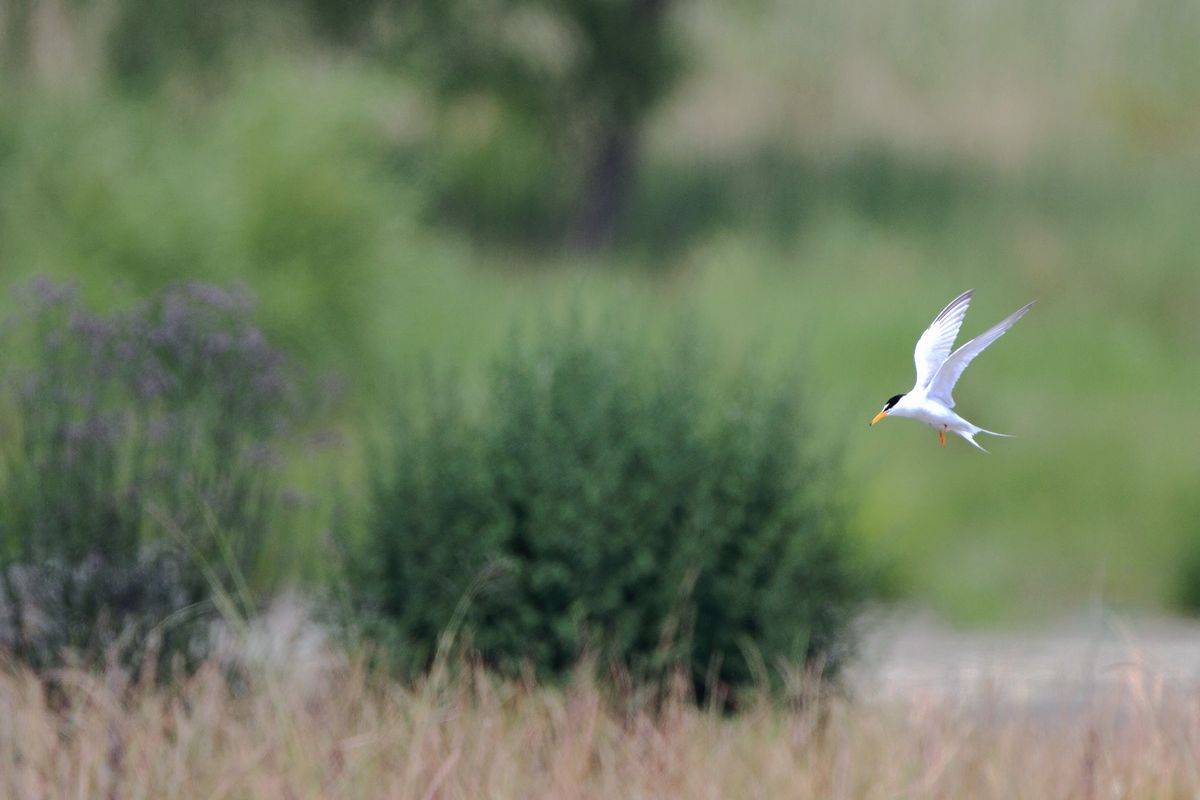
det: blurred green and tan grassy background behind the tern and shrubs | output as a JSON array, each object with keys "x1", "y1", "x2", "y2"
[{"x1": 0, "y1": 0, "x2": 1200, "y2": 621}]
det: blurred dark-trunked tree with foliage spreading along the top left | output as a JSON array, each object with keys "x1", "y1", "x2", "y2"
[{"x1": 0, "y1": 0, "x2": 680, "y2": 249}]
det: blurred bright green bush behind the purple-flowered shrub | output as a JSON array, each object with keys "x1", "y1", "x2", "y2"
[{"x1": 0, "y1": 68, "x2": 403, "y2": 368}]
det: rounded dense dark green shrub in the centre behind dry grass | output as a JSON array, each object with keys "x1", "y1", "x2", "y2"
[{"x1": 362, "y1": 321, "x2": 858, "y2": 692}]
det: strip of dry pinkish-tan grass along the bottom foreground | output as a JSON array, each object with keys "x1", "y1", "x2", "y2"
[{"x1": 0, "y1": 662, "x2": 1200, "y2": 800}]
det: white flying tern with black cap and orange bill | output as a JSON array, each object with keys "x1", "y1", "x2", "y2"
[{"x1": 871, "y1": 289, "x2": 1033, "y2": 452}]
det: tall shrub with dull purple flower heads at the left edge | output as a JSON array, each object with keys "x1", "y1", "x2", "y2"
[{"x1": 0, "y1": 281, "x2": 314, "y2": 666}]
